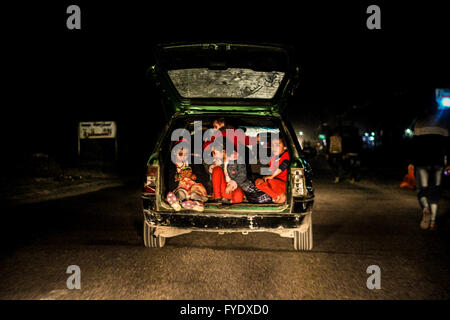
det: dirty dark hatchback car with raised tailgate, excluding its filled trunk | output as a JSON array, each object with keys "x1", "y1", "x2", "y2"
[{"x1": 142, "y1": 42, "x2": 314, "y2": 250}]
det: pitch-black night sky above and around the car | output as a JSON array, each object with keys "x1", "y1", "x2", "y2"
[{"x1": 1, "y1": 0, "x2": 450, "y2": 175}]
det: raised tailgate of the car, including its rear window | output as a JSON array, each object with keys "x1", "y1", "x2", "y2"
[{"x1": 149, "y1": 42, "x2": 298, "y2": 114}]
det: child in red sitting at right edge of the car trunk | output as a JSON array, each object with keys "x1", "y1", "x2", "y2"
[{"x1": 255, "y1": 139, "x2": 290, "y2": 203}]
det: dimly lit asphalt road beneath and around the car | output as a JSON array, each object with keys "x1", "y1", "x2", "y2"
[{"x1": 0, "y1": 165, "x2": 450, "y2": 299}]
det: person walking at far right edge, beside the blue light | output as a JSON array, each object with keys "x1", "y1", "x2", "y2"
[{"x1": 410, "y1": 109, "x2": 450, "y2": 230}]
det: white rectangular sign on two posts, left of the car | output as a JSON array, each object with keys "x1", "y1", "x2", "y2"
[{"x1": 78, "y1": 121, "x2": 117, "y2": 160}]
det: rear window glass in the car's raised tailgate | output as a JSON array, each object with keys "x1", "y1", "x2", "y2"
[{"x1": 168, "y1": 68, "x2": 284, "y2": 99}]
